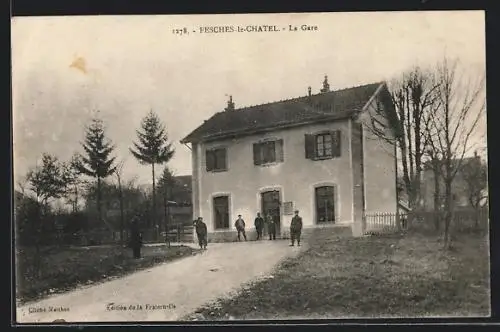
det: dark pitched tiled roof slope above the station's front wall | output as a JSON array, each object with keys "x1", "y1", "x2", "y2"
[{"x1": 181, "y1": 82, "x2": 384, "y2": 143}]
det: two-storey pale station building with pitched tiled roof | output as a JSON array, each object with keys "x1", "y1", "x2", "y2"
[{"x1": 181, "y1": 77, "x2": 397, "y2": 239}]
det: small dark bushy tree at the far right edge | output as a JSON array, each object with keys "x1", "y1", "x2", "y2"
[{"x1": 461, "y1": 155, "x2": 488, "y2": 228}]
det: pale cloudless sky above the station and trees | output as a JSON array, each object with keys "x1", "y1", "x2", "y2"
[{"x1": 12, "y1": 11, "x2": 486, "y2": 184}]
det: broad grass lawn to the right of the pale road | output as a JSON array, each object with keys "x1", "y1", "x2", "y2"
[{"x1": 186, "y1": 231, "x2": 490, "y2": 320}]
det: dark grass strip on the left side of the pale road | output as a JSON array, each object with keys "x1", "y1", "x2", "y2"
[{"x1": 16, "y1": 245, "x2": 198, "y2": 304}]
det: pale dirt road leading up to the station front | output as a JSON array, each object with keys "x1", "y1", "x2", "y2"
[{"x1": 17, "y1": 241, "x2": 304, "y2": 323}]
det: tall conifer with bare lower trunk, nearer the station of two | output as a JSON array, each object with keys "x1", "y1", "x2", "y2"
[{"x1": 130, "y1": 110, "x2": 175, "y2": 233}]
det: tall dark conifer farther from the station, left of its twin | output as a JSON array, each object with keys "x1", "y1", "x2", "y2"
[{"x1": 75, "y1": 118, "x2": 116, "y2": 230}]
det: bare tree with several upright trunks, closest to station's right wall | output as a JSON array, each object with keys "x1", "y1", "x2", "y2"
[{"x1": 367, "y1": 67, "x2": 437, "y2": 220}]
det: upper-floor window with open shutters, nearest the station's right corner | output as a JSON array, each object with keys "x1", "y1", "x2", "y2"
[{"x1": 305, "y1": 130, "x2": 341, "y2": 160}]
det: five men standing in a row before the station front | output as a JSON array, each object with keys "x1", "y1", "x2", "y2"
[{"x1": 193, "y1": 210, "x2": 302, "y2": 249}]
